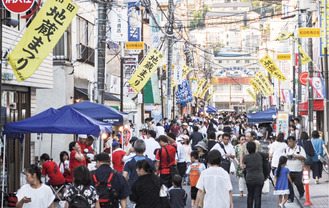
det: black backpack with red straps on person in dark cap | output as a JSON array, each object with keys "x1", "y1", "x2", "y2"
[{"x1": 93, "y1": 171, "x2": 119, "y2": 208}]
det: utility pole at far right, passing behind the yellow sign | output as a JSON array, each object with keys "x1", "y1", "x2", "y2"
[{"x1": 307, "y1": 11, "x2": 313, "y2": 135}]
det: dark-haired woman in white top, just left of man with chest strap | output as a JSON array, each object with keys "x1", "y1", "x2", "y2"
[{"x1": 270, "y1": 133, "x2": 288, "y2": 174}]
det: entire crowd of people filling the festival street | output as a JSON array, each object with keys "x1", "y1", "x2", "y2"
[{"x1": 17, "y1": 113, "x2": 328, "y2": 208}]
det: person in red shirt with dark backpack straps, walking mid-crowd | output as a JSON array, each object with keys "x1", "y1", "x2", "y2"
[{"x1": 155, "y1": 135, "x2": 177, "y2": 188}]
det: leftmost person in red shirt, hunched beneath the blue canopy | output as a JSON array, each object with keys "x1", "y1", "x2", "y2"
[{"x1": 40, "y1": 153, "x2": 65, "y2": 186}]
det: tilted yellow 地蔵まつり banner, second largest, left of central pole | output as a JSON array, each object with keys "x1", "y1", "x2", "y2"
[{"x1": 128, "y1": 48, "x2": 165, "y2": 93}]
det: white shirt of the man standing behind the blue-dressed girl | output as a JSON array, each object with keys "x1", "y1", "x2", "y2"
[{"x1": 285, "y1": 144, "x2": 306, "y2": 172}]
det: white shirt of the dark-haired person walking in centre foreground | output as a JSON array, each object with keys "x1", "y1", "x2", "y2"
[{"x1": 196, "y1": 167, "x2": 232, "y2": 208}]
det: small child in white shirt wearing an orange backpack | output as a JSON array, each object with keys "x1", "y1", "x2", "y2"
[{"x1": 186, "y1": 151, "x2": 206, "y2": 207}]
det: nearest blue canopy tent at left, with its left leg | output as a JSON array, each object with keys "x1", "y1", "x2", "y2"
[{"x1": 1, "y1": 108, "x2": 112, "y2": 207}]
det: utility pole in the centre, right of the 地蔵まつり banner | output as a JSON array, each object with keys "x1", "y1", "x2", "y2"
[{"x1": 166, "y1": 0, "x2": 174, "y2": 119}]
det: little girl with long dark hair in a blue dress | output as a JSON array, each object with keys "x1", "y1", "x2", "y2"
[{"x1": 273, "y1": 156, "x2": 292, "y2": 208}]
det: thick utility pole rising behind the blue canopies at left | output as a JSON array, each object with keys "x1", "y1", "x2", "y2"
[{"x1": 97, "y1": 1, "x2": 107, "y2": 104}]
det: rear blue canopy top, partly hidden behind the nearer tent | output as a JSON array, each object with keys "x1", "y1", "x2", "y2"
[{"x1": 58, "y1": 101, "x2": 128, "y2": 125}]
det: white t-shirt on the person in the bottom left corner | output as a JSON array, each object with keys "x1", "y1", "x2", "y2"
[{"x1": 16, "y1": 184, "x2": 55, "y2": 208}]
